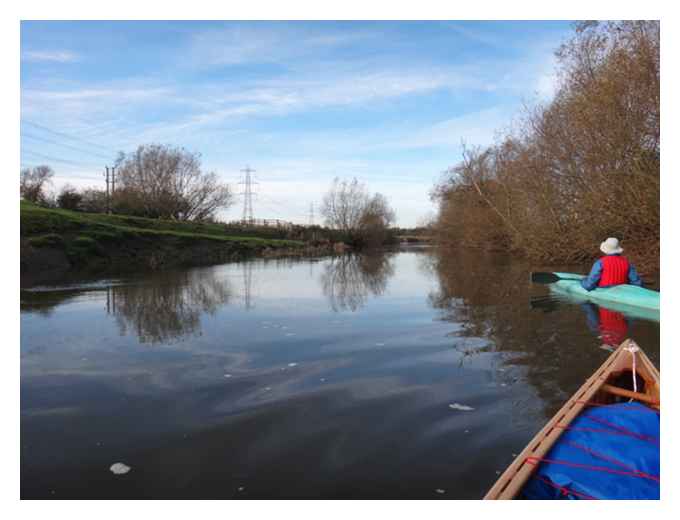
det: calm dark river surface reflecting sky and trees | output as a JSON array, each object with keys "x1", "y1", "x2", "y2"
[{"x1": 21, "y1": 249, "x2": 659, "y2": 499}]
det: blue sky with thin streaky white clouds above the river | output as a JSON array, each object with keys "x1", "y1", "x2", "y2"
[{"x1": 21, "y1": 21, "x2": 571, "y2": 226}]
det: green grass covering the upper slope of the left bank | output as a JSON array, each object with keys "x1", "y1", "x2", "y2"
[{"x1": 21, "y1": 201, "x2": 304, "y2": 249}]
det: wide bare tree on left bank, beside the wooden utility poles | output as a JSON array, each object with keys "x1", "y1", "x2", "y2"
[{"x1": 117, "y1": 144, "x2": 234, "y2": 220}]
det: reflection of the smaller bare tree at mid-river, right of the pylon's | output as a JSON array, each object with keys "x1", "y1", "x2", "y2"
[{"x1": 321, "y1": 251, "x2": 394, "y2": 312}]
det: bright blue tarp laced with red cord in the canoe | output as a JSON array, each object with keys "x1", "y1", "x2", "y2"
[{"x1": 522, "y1": 402, "x2": 660, "y2": 500}]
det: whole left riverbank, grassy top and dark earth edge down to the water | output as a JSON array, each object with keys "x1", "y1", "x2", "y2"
[{"x1": 20, "y1": 201, "x2": 333, "y2": 285}]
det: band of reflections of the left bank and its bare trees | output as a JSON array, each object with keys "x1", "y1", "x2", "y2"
[{"x1": 21, "y1": 251, "x2": 395, "y2": 345}]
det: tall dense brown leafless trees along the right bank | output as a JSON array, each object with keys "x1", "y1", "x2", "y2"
[{"x1": 432, "y1": 21, "x2": 660, "y2": 270}]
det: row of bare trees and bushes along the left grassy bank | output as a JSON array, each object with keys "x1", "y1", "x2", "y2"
[{"x1": 20, "y1": 144, "x2": 396, "y2": 247}]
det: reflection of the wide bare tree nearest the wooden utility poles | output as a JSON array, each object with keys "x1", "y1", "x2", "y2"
[{"x1": 107, "y1": 269, "x2": 233, "y2": 344}]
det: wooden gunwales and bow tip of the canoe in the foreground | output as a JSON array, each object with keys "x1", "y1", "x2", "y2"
[{"x1": 484, "y1": 339, "x2": 661, "y2": 500}]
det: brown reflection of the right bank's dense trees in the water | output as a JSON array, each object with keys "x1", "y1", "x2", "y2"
[{"x1": 427, "y1": 249, "x2": 658, "y2": 416}]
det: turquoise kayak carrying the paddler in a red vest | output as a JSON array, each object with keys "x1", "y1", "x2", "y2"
[{"x1": 550, "y1": 273, "x2": 660, "y2": 312}]
